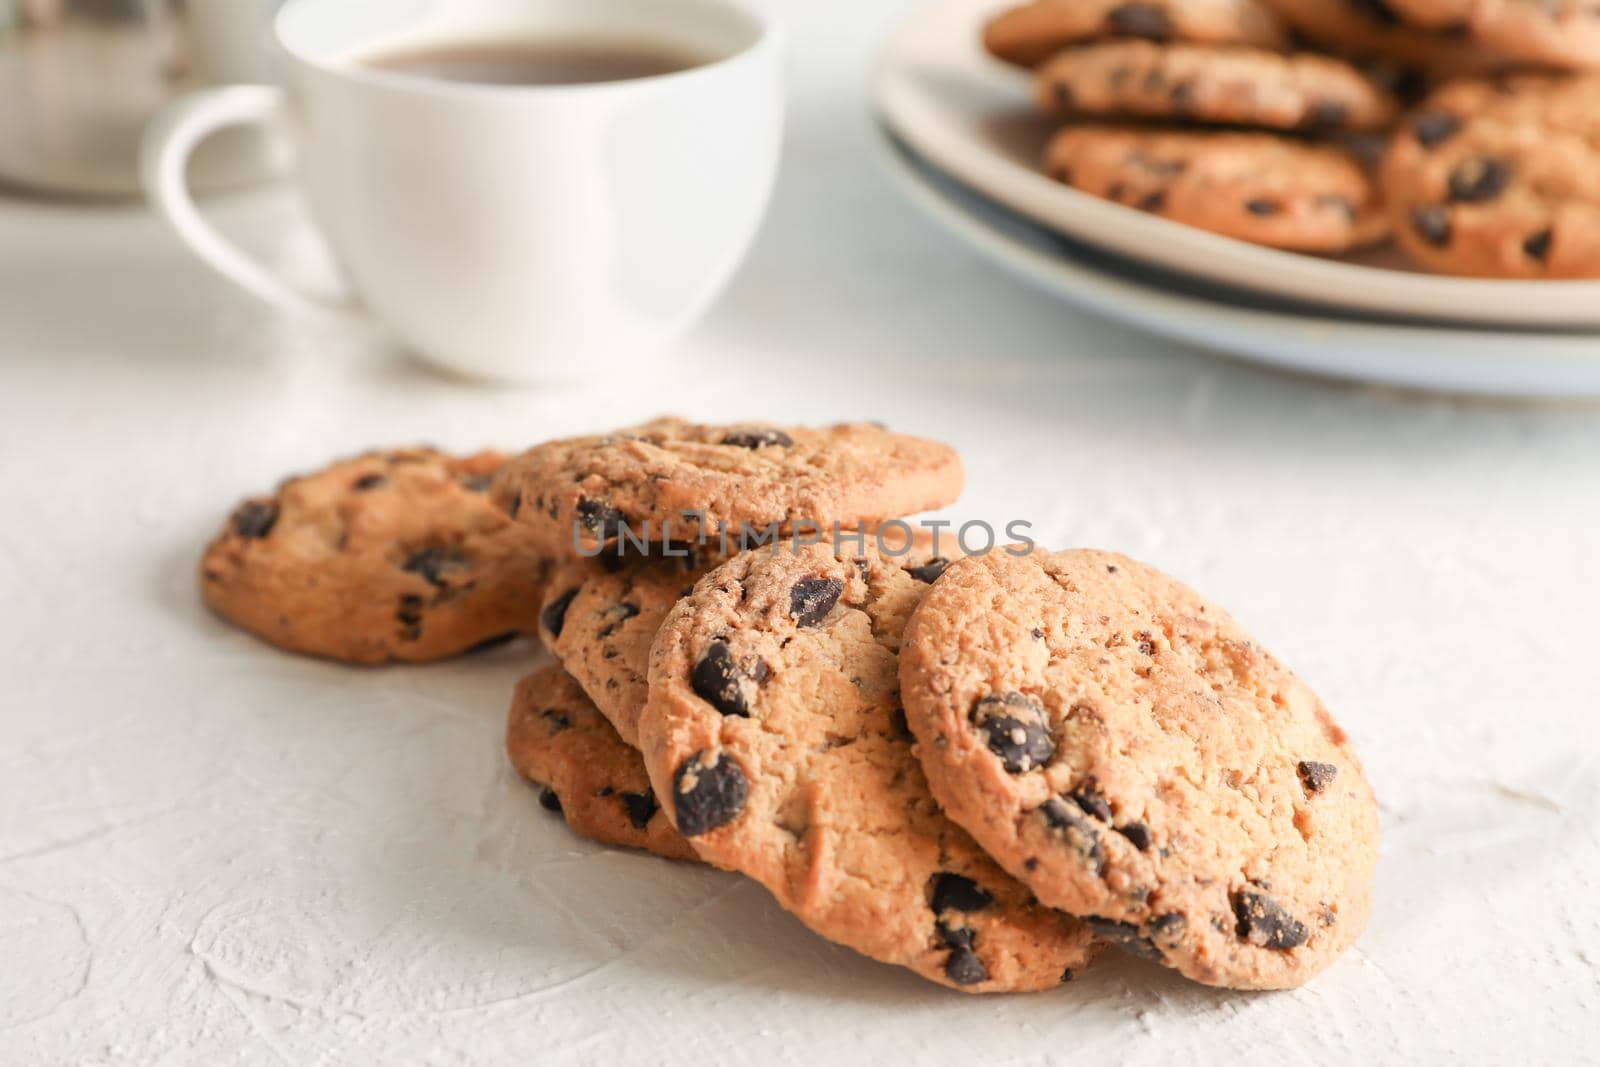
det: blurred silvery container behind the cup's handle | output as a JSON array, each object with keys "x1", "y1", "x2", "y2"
[{"x1": 0, "y1": 0, "x2": 283, "y2": 197}]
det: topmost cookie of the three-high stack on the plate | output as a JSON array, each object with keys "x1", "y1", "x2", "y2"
[{"x1": 984, "y1": 0, "x2": 1288, "y2": 67}]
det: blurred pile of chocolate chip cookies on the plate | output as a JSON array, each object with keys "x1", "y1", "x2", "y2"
[{"x1": 984, "y1": 0, "x2": 1600, "y2": 278}]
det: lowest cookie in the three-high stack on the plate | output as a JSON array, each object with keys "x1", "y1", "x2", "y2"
[{"x1": 1046, "y1": 126, "x2": 1389, "y2": 253}]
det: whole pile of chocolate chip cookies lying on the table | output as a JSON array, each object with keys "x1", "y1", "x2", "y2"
[{"x1": 202, "y1": 419, "x2": 1378, "y2": 992}]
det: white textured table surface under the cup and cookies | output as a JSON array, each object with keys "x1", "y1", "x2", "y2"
[{"x1": 0, "y1": 0, "x2": 1600, "y2": 1065}]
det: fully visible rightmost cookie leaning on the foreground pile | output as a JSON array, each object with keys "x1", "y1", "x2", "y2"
[{"x1": 899, "y1": 550, "x2": 1378, "y2": 989}]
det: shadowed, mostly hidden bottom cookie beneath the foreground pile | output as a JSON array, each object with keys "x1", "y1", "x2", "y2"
[{"x1": 506, "y1": 665, "x2": 699, "y2": 859}]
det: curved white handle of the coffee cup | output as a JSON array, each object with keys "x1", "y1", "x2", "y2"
[{"x1": 139, "y1": 85, "x2": 358, "y2": 320}]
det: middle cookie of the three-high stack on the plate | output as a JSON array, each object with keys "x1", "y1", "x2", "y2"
[{"x1": 1034, "y1": 40, "x2": 1398, "y2": 131}]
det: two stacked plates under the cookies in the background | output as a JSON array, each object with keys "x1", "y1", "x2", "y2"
[{"x1": 874, "y1": 0, "x2": 1600, "y2": 397}]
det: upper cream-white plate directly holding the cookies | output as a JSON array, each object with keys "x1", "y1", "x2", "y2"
[{"x1": 874, "y1": 0, "x2": 1600, "y2": 328}]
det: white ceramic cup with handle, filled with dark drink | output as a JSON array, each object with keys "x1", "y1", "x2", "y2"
[{"x1": 141, "y1": 0, "x2": 784, "y2": 381}]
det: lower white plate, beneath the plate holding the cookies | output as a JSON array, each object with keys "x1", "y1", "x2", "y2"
[{"x1": 882, "y1": 131, "x2": 1600, "y2": 397}]
